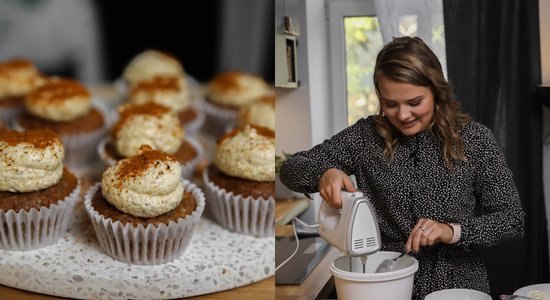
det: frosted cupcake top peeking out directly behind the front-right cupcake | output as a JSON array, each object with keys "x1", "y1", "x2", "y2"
[{"x1": 237, "y1": 95, "x2": 275, "y2": 131}]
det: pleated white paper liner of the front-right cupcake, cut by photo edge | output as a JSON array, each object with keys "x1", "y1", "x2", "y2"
[{"x1": 202, "y1": 168, "x2": 275, "y2": 237}]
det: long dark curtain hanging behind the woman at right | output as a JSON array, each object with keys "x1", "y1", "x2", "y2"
[{"x1": 443, "y1": 0, "x2": 549, "y2": 299}]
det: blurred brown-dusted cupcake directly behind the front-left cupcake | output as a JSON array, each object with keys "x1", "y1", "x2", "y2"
[{"x1": 14, "y1": 77, "x2": 106, "y2": 169}]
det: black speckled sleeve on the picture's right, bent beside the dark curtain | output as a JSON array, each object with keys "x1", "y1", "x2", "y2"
[{"x1": 458, "y1": 123, "x2": 524, "y2": 247}]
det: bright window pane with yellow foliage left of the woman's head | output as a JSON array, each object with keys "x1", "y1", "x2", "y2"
[{"x1": 344, "y1": 16, "x2": 383, "y2": 125}]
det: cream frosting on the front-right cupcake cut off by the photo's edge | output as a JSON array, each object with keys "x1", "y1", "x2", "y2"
[{"x1": 214, "y1": 126, "x2": 275, "y2": 181}]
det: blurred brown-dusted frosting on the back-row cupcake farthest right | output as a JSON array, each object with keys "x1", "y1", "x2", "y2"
[{"x1": 205, "y1": 71, "x2": 273, "y2": 107}]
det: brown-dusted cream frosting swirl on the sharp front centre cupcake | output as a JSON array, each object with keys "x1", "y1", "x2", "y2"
[{"x1": 101, "y1": 147, "x2": 183, "y2": 218}]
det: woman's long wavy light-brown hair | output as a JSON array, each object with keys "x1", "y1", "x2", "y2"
[{"x1": 373, "y1": 37, "x2": 471, "y2": 169}]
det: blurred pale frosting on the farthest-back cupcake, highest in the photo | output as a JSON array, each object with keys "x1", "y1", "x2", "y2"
[{"x1": 122, "y1": 50, "x2": 185, "y2": 86}]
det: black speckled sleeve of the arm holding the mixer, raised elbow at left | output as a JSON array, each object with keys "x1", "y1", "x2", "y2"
[{"x1": 279, "y1": 119, "x2": 366, "y2": 194}]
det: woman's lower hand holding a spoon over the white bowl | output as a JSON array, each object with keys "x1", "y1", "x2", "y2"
[{"x1": 405, "y1": 218, "x2": 453, "y2": 252}]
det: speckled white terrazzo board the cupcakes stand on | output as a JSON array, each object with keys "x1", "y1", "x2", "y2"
[{"x1": 0, "y1": 192, "x2": 275, "y2": 299}]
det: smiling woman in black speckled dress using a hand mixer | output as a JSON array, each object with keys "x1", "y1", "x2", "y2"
[{"x1": 280, "y1": 37, "x2": 524, "y2": 299}]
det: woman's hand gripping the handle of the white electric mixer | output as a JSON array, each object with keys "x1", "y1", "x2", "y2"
[{"x1": 319, "y1": 169, "x2": 356, "y2": 208}]
